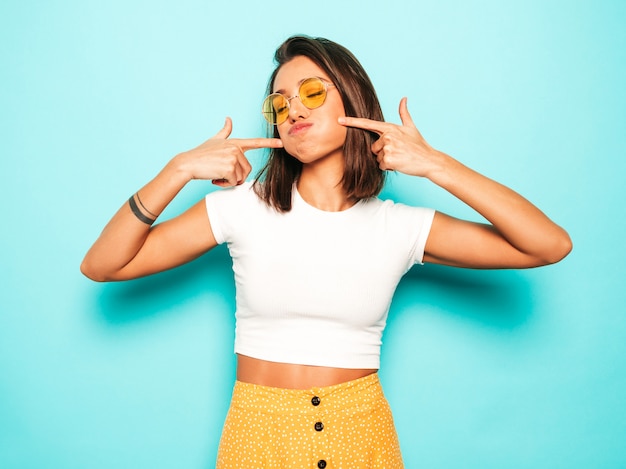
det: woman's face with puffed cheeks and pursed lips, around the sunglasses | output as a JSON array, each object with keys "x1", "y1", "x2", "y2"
[{"x1": 272, "y1": 56, "x2": 347, "y2": 164}]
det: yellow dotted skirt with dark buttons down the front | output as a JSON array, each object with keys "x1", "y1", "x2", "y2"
[{"x1": 217, "y1": 373, "x2": 404, "y2": 469}]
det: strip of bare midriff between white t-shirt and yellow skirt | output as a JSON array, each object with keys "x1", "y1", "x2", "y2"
[{"x1": 237, "y1": 355, "x2": 378, "y2": 389}]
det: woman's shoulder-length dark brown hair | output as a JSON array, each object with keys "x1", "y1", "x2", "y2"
[{"x1": 254, "y1": 36, "x2": 385, "y2": 212}]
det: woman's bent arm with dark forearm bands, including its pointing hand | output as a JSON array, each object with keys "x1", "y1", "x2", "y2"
[{"x1": 81, "y1": 119, "x2": 282, "y2": 281}]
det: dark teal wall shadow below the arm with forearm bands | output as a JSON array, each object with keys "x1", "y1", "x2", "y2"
[{"x1": 98, "y1": 245, "x2": 235, "y2": 325}]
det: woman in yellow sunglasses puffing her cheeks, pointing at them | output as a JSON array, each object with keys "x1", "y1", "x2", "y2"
[{"x1": 81, "y1": 37, "x2": 571, "y2": 469}]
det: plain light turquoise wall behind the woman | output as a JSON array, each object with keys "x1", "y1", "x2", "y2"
[{"x1": 0, "y1": 0, "x2": 626, "y2": 469}]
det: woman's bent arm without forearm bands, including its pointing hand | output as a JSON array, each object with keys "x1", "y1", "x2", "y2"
[{"x1": 340, "y1": 98, "x2": 572, "y2": 268}]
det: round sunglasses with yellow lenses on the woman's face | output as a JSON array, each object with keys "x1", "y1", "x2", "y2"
[{"x1": 262, "y1": 77, "x2": 335, "y2": 125}]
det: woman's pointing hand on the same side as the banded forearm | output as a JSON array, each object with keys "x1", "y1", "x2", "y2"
[{"x1": 172, "y1": 117, "x2": 283, "y2": 187}]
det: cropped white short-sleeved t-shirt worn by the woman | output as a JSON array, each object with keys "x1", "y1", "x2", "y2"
[{"x1": 206, "y1": 183, "x2": 434, "y2": 369}]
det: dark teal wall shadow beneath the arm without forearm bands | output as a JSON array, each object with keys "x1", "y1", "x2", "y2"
[{"x1": 390, "y1": 264, "x2": 534, "y2": 330}]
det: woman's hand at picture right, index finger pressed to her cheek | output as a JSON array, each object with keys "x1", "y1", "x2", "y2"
[{"x1": 339, "y1": 98, "x2": 443, "y2": 177}]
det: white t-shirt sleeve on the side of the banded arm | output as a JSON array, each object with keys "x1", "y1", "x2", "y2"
[{"x1": 205, "y1": 182, "x2": 253, "y2": 244}]
